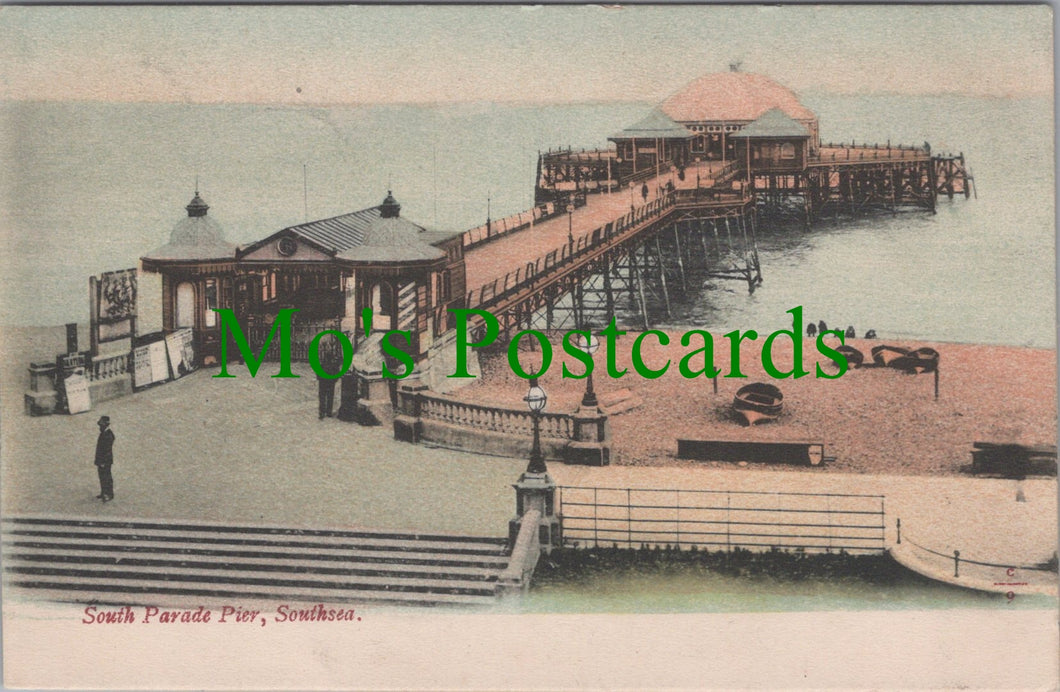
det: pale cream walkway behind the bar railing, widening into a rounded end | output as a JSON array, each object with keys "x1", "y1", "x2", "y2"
[{"x1": 549, "y1": 463, "x2": 1057, "y2": 597}]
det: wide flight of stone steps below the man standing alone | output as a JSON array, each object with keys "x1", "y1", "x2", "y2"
[{"x1": 2, "y1": 517, "x2": 508, "y2": 606}]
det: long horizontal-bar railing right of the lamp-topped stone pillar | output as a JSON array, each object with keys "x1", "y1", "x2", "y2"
[{"x1": 559, "y1": 485, "x2": 885, "y2": 553}]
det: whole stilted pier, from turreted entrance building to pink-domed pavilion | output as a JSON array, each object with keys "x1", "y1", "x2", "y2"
[{"x1": 120, "y1": 71, "x2": 974, "y2": 375}]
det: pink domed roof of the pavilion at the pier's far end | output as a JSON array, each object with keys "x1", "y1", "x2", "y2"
[{"x1": 660, "y1": 72, "x2": 817, "y2": 123}]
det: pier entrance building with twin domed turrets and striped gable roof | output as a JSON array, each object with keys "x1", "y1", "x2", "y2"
[{"x1": 142, "y1": 192, "x2": 464, "y2": 365}]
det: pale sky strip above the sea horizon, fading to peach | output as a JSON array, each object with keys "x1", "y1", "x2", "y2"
[{"x1": 0, "y1": 5, "x2": 1053, "y2": 104}]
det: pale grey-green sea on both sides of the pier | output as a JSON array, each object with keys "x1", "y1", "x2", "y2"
[{"x1": 0, "y1": 93, "x2": 1056, "y2": 348}]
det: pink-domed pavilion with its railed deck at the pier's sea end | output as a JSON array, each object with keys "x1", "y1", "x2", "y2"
[{"x1": 534, "y1": 66, "x2": 972, "y2": 221}]
